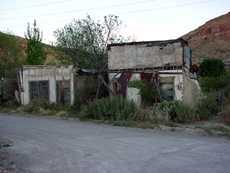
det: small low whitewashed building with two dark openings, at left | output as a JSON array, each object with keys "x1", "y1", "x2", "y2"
[{"x1": 18, "y1": 65, "x2": 74, "y2": 105}]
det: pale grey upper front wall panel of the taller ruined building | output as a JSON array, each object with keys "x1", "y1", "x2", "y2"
[{"x1": 108, "y1": 42, "x2": 183, "y2": 70}]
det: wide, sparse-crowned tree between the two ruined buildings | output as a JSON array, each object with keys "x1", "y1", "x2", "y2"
[{"x1": 54, "y1": 15, "x2": 129, "y2": 69}]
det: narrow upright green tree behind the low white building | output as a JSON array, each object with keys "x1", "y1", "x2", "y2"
[{"x1": 25, "y1": 20, "x2": 45, "y2": 65}]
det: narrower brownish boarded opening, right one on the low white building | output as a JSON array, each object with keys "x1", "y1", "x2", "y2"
[{"x1": 56, "y1": 80, "x2": 70, "y2": 104}]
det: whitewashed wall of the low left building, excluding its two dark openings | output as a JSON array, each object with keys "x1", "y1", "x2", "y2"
[{"x1": 20, "y1": 66, "x2": 74, "y2": 105}]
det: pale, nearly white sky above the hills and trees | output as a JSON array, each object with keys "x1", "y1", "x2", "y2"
[{"x1": 0, "y1": 0, "x2": 230, "y2": 44}]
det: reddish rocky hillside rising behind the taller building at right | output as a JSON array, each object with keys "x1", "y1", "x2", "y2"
[{"x1": 183, "y1": 12, "x2": 230, "y2": 63}]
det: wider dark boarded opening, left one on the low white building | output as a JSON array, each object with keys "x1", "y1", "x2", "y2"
[{"x1": 29, "y1": 81, "x2": 49, "y2": 100}]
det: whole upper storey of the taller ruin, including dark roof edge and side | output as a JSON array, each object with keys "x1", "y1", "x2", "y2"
[{"x1": 108, "y1": 39, "x2": 191, "y2": 70}]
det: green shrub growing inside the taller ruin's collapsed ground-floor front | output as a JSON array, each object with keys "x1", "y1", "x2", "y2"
[{"x1": 128, "y1": 80, "x2": 158, "y2": 105}]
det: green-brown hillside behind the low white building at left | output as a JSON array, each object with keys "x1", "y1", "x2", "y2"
[{"x1": 0, "y1": 32, "x2": 70, "y2": 68}]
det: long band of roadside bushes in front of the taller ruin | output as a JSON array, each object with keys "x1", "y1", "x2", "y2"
[{"x1": 80, "y1": 97, "x2": 200, "y2": 123}]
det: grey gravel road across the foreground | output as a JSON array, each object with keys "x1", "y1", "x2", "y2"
[{"x1": 0, "y1": 114, "x2": 230, "y2": 173}]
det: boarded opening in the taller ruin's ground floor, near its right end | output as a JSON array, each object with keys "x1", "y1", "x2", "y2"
[{"x1": 160, "y1": 77, "x2": 175, "y2": 101}]
